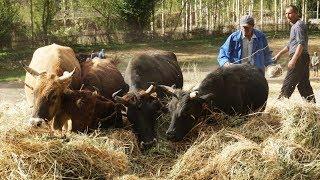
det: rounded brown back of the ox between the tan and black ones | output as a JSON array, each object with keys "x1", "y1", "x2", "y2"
[{"x1": 81, "y1": 58, "x2": 129, "y2": 98}]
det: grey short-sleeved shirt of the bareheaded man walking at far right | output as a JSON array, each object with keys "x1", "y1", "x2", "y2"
[{"x1": 287, "y1": 19, "x2": 308, "y2": 55}]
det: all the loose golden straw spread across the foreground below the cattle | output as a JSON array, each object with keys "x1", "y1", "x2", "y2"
[{"x1": 0, "y1": 89, "x2": 320, "y2": 180}]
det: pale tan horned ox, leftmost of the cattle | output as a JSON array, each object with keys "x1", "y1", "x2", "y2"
[{"x1": 24, "y1": 44, "x2": 81, "y2": 130}]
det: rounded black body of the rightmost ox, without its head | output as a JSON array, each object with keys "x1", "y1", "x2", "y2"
[{"x1": 198, "y1": 64, "x2": 269, "y2": 115}]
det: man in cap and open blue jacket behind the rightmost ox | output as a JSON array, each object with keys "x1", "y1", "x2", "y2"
[{"x1": 218, "y1": 15, "x2": 272, "y2": 75}]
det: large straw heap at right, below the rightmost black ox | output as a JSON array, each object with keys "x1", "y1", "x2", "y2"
[{"x1": 167, "y1": 100, "x2": 320, "y2": 179}]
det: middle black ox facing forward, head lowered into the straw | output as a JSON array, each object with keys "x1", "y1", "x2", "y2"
[{"x1": 114, "y1": 51, "x2": 183, "y2": 148}]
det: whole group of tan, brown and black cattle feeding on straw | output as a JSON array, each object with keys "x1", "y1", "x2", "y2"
[{"x1": 23, "y1": 44, "x2": 269, "y2": 149}]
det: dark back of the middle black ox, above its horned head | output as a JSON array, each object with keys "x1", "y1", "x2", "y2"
[{"x1": 125, "y1": 51, "x2": 183, "y2": 90}]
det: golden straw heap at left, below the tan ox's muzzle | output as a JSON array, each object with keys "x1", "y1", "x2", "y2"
[{"x1": 0, "y1": 101, "x2": 134, "y2": 179}]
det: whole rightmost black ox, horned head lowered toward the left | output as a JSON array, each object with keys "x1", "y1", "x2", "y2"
[{"x1": 158, "y1": 64, "x2": 269, "y2": 141}]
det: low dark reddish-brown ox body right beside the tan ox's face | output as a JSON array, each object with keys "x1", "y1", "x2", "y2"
[{"x1": 54, "y1": 89, "x2": 123, "y2": 132}]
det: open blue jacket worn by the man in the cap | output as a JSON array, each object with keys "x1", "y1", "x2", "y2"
[{"x1": 218, "y1": 29, "x2": 272, "y2": 71}]
